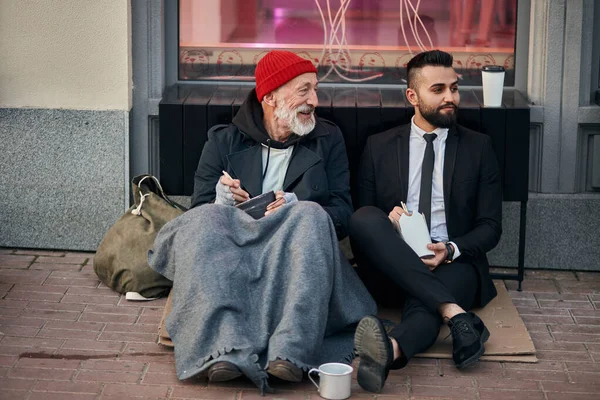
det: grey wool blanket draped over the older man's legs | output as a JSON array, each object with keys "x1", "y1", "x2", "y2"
[{"x1": 149, "y1": 201, "x2": 376, "y2": 393}]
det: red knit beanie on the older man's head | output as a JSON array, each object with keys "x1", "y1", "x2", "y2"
[{"x1": 254, "y1": 50, "x2": 317, "y2": 102}]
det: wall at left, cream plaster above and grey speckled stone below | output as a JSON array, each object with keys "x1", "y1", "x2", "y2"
[{"x1": 0, "y1": 0, "x2": 132, "y2": 250}]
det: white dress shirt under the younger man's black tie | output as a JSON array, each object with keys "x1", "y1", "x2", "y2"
[{"x1": 406, "y1": 117, "x2": 460, "y2": 260}]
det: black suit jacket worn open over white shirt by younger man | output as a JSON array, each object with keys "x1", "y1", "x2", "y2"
[{"x1": 356, "y1": 124, "x2": 502, "y2": 306}]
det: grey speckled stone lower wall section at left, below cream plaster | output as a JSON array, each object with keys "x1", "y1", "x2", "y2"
[{"x1": 0, "y1": 108, "x2": 129, "y2": 250}]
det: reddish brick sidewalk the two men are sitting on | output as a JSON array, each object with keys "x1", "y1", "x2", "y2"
[{"x1": 0, "y1": 248, "x2": 600, "y2": 400}]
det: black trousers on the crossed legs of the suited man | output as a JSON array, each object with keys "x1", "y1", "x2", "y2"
[{"x1": 350, "y1": 207, "x2": 479, "y2": 368}]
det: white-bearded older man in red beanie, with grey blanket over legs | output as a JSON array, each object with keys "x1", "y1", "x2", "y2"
[{"x1": 150, "y1": 51, "x2": 376, "y2": 392}]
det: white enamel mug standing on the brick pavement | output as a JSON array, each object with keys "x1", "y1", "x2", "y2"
[{"x1": 308, "y1": 363, "x2": 353, "y2": 400}]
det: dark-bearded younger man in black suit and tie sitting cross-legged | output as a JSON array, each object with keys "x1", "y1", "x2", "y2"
[{"x1": 350, "y1": 50, "x2": 502, "y2": 392}]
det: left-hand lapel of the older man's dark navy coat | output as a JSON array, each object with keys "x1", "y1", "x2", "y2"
[{"x1": 227, "y1": 145, "x2": 262, "y2": 197}]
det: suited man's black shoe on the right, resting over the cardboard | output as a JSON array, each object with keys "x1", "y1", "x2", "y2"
[{"x1": 448, "y1": 312, "x2": 490, "y2": 369}]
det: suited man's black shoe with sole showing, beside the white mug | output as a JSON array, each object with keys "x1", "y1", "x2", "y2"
[{"x1": 354, "y1": 315, "x2": 394, "y2": 393}]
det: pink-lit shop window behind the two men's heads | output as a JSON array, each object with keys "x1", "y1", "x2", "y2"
[{"x1": 178, "y1": 0, "x2": 517, "y2": 86}]
